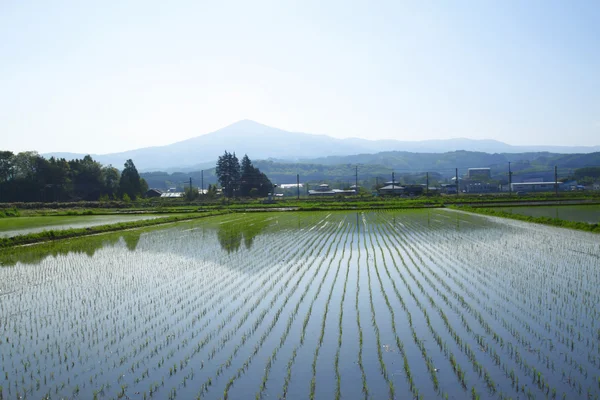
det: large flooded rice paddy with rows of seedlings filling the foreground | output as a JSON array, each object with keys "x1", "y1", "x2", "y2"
[{"x1": 0, "y1": 210, "x2": 600, "y2": 399}]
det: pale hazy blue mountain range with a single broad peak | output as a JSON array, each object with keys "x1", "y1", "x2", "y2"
[{"x1": 43, "y1": 120, "x2": 600, "y2": 171}]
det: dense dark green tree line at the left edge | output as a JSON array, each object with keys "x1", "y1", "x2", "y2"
[{"x1": 0, "y1": 151, "x2": 148, "y2": 202}]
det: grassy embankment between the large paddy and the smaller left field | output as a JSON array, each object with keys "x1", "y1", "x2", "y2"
[{"x1": 0, "y1": 211, "x2": 227, "y2": 248}]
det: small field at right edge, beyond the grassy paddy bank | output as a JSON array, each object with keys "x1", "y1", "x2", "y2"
[{"x1": 495, "y1": 205, "x2": 600, "y2": 224}]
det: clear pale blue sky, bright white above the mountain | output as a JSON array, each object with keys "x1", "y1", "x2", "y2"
[{"x1": 0, "y1": 0, "x2": 600, "y2": 154}]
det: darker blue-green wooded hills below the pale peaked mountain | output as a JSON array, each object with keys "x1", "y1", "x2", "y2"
[{"x1": 141, "y1": 150, "x2": 600, "y2": 188}]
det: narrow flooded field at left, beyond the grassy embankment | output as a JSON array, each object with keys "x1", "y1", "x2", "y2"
[{"x1": 0, "y1": 214, "x2": 173, "y2": 237}]
